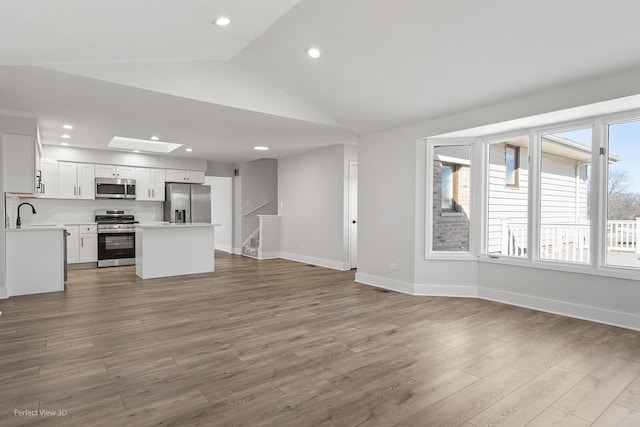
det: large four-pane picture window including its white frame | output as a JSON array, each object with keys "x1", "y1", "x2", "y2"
[{"x1": 426, "y1": 111, "x2": 640, "y2": 279}]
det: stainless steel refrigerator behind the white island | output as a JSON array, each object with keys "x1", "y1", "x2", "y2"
[{"x1": 164, "y1": 184, "x2": 211, "y2": 224}]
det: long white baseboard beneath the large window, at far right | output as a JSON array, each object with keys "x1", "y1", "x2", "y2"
[{"x1": 478, "y1": 287, "x2": 640, "y2": 331}]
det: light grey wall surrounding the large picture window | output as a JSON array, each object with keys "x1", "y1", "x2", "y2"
[{"x1": 356, "y1": 66, "x2": 640, "y2": 329}]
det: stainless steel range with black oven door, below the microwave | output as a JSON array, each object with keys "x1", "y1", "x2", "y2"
[{"x1": 95, "y1": 209, "x2": 138, "y2": 267}]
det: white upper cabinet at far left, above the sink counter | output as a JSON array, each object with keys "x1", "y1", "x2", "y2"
[{"x1": 2, "y1": 134, "x2": 41, "y2": 196}]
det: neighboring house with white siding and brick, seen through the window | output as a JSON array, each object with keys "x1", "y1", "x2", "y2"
[{"x1": 433, "y1": 135, "x2": 604, "y2": 258}]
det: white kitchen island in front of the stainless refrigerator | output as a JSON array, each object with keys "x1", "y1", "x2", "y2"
[{"x1": 136, "y1": 223, "x2": 214, "y2": 279}]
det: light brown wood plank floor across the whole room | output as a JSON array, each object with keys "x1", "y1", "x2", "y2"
[{"x1": 0, "y1": 253, "x2": 640, "y2": 427}]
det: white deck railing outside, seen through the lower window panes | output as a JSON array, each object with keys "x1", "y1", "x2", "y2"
[{"x1": 501, "y1": 218, "x2": 640, "y2": 262}]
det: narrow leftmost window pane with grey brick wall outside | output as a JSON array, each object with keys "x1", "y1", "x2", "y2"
[{"x1": 431, "y1": 145, "x2": 471, "y2": 252}]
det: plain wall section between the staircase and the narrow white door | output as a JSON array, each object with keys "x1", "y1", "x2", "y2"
[{"x1": 278, "y1": 145, "x2": 357, "y2": 270}]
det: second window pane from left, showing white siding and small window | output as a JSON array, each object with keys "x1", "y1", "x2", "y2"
[{"x1": 486, "y1": 136, "x2": 529, "y2": 257}]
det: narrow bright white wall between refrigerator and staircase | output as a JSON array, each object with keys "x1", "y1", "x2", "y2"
[{"x1": 204, "y1": 176, "x2": 233, "y2": 252}]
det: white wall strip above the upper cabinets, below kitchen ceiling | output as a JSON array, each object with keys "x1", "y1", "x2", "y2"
[{"x1": 42, "y1": 145, "x2": 207, "y2": 171}]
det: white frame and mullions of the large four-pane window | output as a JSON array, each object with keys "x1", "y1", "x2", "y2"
[{"x1": 422, "y1": 108, "x2": 640, "y2": 280}]
